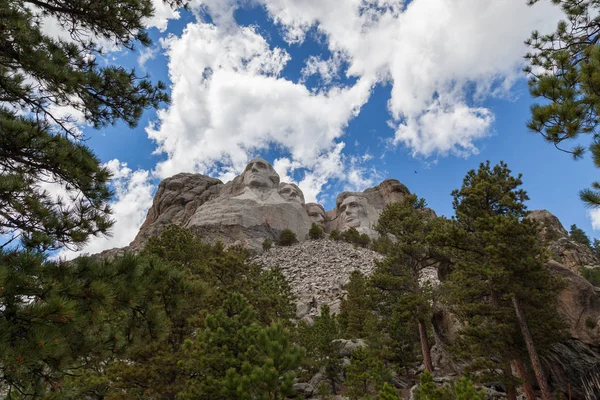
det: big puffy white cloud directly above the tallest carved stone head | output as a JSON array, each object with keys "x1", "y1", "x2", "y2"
[{"x1": 147, "y1": 23, "x2": 371, "y2": 195}]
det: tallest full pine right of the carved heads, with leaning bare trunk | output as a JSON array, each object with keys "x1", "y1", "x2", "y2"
[{"x1": 447, "y1": 162, "x2": 564, "y2": 399}]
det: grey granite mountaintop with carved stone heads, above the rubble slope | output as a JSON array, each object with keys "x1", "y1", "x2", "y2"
[{"x1": 131, "y1": 158, "x2": 410, "y2": 249}]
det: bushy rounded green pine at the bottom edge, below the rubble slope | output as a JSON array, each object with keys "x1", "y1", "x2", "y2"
[{"x1": 178, "y1": 294, "x2": 302, "y2": 400}]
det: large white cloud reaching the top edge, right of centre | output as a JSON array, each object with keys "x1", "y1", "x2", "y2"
[{"x1": 262, "y1": 0, "x2": 559, "y2": 156}]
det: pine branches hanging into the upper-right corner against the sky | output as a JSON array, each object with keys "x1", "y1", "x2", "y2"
[{"x1": 526, "y1": 0, "x2": 600, "y2": 207}]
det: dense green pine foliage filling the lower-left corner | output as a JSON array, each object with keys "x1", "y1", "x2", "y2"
[{"x1": 0, "y1": 251, "x2": 183, "y2": 396}]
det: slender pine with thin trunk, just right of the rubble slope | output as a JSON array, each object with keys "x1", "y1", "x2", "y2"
[{"x1": 372, "y1": 195, "x2": 437, "y2": 371}]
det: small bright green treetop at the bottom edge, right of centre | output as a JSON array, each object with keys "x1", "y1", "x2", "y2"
[{"x1": 415, "y1": 372, "x2": 486, "y2": 400}]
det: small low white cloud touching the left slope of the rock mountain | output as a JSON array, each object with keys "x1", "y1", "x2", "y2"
[{"x1": 59, "y1": 159, "x2": 155, "y2": 259}]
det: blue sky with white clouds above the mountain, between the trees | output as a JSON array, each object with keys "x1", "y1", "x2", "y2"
[{"x1": 63, "y1": 0, "x2": 600, "y2": 252}]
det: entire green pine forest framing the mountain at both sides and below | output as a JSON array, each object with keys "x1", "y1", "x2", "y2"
[{"x1": 0, "y1": 0, "x2": 600, "y2": 400}]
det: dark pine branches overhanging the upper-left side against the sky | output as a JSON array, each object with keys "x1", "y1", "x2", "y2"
[{"x1": 0, "y1": 0, "x2": 172, "y2": 250}]
